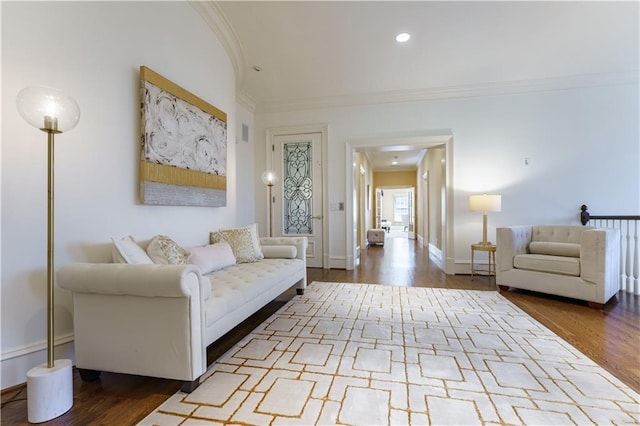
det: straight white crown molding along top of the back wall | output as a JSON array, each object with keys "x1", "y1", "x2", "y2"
[{"x1": 256, "y1": 70, "x2": 638, "y2": 113}]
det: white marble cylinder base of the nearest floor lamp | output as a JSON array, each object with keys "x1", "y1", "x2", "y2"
[{"x1": 27, "y1": 359, "x2": 73, "y2": 423}]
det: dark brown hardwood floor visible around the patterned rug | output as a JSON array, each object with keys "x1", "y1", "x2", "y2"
[{"x1": 0, "y1": 238, "x2": 640, "y2": 425}]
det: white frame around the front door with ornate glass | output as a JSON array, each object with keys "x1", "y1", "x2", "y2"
[{"x1": 265, "y1": 124, "x2": 330, "y2": 269}]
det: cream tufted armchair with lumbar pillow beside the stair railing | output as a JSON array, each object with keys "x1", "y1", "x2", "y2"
[{"x1": 496, "y1": 226, "x2": 620, "y2": 308}]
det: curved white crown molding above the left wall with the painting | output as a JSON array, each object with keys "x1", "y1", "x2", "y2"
[{"x1": 189, "y1": 0, "x2": 245, "y2": 89}]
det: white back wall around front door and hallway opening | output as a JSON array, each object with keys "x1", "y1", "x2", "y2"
[{"x1": 255, "y1": 84, "x2": 640, "y2": 270}]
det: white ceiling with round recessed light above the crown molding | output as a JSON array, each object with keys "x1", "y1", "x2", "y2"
[{"x1": 214, "y1": 1, "x2": 639, "y2": 170}]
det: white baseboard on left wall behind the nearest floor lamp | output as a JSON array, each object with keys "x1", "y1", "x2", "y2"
[{"x1": 0, "y1": 334, "x2": 75, "y2": 389}]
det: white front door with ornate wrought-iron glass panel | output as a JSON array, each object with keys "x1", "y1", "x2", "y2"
[{"x1": 272, "y1": 133, "x2": 323, "y2": 268}]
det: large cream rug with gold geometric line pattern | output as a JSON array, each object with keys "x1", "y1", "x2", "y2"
[{"x1": 140, "y1": 282, "x2": 640, "y2": 425}]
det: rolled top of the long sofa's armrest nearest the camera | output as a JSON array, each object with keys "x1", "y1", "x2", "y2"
[{"x1": 57, "y1": 263, "x2": 201, "y2": 297}]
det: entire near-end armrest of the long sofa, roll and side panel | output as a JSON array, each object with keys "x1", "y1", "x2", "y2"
[{"x1": 57, "y1": 263, "x2": 207, "y2": 382}]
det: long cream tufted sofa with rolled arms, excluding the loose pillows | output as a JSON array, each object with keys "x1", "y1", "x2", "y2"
[{"x1": 57, "y1": 237, "x2": 307, "y2": 392}]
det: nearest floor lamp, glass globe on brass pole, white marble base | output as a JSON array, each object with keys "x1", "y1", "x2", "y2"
[{"x1": 17, "y1": 87, "x2": 80, "y2": 423}]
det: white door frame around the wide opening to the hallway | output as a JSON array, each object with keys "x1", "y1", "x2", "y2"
[{"x1": 345, "y1": 129, "x2": 455, "y2": 275}]
